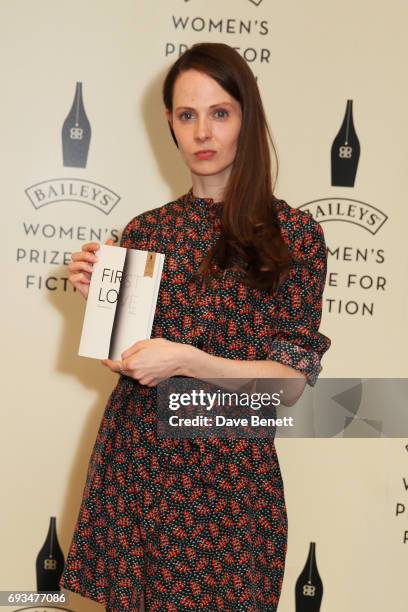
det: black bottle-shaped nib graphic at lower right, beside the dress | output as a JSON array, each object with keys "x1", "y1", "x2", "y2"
[{"x1": 295, "y1": 542, "x2": 323, "y2": 612}]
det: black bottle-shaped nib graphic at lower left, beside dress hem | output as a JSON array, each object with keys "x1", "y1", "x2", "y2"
[{"x1": 35, "y1": 516, "x2": 64, "y2": 592}]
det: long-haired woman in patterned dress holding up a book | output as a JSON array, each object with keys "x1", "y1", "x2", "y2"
[{"x1": 61, "y1": 43, "x2": 330, "y2": 612}]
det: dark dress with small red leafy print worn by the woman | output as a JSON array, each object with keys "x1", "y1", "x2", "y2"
[{"x1": 60, "y1": 189, "x2": 330, "y2": 612}]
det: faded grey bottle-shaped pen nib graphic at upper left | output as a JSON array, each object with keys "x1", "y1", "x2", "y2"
[{"x1": 62, "y1": 82, "x2": 91, "y2": 168}]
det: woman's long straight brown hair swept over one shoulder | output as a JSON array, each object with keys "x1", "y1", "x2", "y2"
[{"x1": 163, "y1": 43, "x2": 292, "y2": 291}]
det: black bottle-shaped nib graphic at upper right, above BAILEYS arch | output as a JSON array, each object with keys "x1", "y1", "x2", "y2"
[{"x1": 331, "y1": 100, "x2": 360, "y2": 187}]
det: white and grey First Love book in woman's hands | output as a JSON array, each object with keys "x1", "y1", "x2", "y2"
[{"x1": 78, "y1": 245, "x2": 165, "y2": 361}]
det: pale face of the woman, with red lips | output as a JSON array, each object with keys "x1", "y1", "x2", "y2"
[{"x1": 166, "y1": 69, "x2": 242, "y2": 180}]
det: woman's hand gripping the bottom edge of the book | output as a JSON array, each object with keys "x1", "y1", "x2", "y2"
[{"x1": 102, "y1": 338, "x2": 194, "y2": 387}]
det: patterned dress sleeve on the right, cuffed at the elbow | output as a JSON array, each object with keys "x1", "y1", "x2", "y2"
[{"x1": 267, "y1": 213, "x2": 331, "y2": 387}]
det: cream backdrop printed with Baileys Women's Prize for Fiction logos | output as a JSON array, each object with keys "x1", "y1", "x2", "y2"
[{"x1": 0, "y1": 0, "x2": 408, "y2": 612}]
